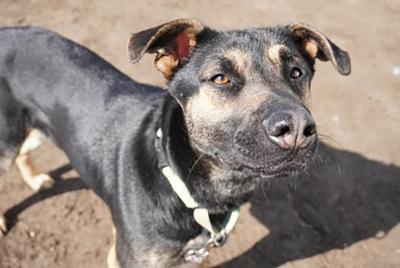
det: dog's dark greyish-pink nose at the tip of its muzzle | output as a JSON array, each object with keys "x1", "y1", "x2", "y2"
[{"x1": 263, "y1": 109, "x2": 317, "y2": 150}]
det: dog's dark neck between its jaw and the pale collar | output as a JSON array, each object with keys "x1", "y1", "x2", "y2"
[{"x1": 158, "y1": 98, "x2": 255, "y2": 214}]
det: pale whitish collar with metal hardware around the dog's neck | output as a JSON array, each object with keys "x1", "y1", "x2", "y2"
[{"x1": 156, "y1": 128, "x2": 239, "y2": 262}]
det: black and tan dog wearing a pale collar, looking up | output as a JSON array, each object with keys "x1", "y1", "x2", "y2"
[{"x1": 0, "y1": 19, "x2": 350, "y2": 267}]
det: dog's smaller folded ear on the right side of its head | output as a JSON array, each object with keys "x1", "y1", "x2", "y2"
[{"x1": 287, "y1": 23, "x2": 351, "y2": 75}]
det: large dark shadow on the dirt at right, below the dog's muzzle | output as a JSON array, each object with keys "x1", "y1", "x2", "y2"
[{"x1": 222, "y1": 145, "x2": 400, "y2": 268}]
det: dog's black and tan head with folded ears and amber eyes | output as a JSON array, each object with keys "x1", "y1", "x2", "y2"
[{"x1": 129, "y1": 20, "x2": 350, "y2": 178}]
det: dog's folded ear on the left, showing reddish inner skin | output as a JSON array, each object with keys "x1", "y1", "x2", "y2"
[{"x1": 129, "y1": 19, "x2": 204, "y2": 79}]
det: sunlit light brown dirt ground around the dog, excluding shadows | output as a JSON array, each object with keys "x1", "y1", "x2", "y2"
[{"x1": 0, "y1": 0, "x2": 400, "y2": 268}]
